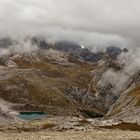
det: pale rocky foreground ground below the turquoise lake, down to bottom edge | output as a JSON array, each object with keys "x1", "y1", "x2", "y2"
[{"x1": 0, "y1": 117, "x2": 140, "y2": 140}]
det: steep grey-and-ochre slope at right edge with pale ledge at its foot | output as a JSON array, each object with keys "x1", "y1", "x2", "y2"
[{"x1": 92, "y1": 72, "x2": 140, "y2": 131}]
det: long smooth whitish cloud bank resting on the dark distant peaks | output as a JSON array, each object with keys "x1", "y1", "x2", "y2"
[{"x1": 46, "y1": 29, "x2": 128, "y2": 52}]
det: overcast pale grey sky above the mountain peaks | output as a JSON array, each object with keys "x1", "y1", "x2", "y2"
[{"x1": 0, "y1": 0, "x2": 140, "y2": 48}]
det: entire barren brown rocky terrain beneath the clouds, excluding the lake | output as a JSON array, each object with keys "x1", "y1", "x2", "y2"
[{"x1": 0, "y1": 39, "x2": 140, "y2": 140}]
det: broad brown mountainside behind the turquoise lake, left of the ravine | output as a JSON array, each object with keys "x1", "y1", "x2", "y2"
[{"x1": 0, "y1": 49, "x2": 104, "y2": 118}]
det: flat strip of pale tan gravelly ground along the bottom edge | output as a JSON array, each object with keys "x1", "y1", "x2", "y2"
[{"x1": 0, "y1": 129, "x2": 140, "y2": 140}]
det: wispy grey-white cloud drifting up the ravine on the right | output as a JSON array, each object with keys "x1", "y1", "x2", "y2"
[{"x1": 98, "y1": 48, "x2": 140, "y2": 106}]
